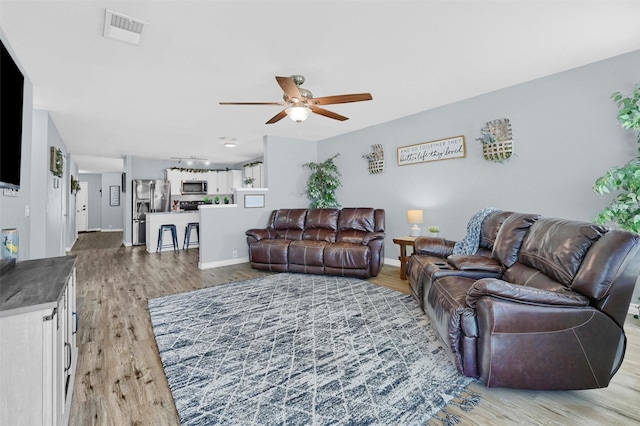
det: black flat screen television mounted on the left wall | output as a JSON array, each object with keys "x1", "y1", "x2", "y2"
[{"x1": 0, "y1": 40, "x2": 24, "y2": 189}]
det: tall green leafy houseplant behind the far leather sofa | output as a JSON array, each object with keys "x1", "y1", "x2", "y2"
[{"x1": 303, "y1": 153, "x2": 342, "y2": 209}]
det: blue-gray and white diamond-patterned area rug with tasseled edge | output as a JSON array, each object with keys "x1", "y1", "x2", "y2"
[{"x1": 149, "y1": 273, "x2": 477, "y2": 425}]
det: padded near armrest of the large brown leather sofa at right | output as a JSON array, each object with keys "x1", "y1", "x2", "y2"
[{"x1": 467, "y1": 278, "x2": 589, "y2": 307}]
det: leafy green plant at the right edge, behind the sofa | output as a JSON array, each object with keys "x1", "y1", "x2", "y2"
[{"x1": 593, "y1": 84, "x2": 640, "y2": 233}]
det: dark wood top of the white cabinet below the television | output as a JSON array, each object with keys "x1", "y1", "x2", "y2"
[{"x1": 0, "y1": 256, "x2": 76, "y2": 317}]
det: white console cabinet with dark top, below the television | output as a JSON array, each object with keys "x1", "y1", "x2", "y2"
[{"x1": 0, "y1": 256, "x2": 78, "y2": 426}]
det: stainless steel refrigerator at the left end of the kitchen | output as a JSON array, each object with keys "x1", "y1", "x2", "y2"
[{"x1": 131, "y1": 179, "x2": 171, "y2": 246}]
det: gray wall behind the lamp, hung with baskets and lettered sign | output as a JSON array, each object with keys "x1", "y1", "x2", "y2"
[{"x1": 318, "y1": 51, "x2": 640, "y2": 301}]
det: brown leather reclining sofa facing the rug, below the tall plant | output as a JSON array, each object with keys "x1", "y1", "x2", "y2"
[{"x1": 246, "y1": 208, "x2": 385, "y2": 278}]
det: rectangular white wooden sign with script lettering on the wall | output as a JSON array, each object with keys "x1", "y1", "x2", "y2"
[{"x1": 398, "y1": 136, "x2": 467, "y2": 166}]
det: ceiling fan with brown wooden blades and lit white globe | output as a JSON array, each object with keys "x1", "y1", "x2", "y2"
[{"x1": 220, "y1": 75, "x2": 373, "y2": 124}]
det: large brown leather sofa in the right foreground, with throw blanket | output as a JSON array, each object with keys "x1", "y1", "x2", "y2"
[{"x1": 407, "y1": 212, "x2": 640, "y2": 390}]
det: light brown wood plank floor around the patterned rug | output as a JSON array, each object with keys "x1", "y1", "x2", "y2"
[{"x1": 70, "y1": 232, "x2": 640, "y2": 426}]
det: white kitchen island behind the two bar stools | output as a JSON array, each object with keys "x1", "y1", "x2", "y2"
[{"x1": 147, "y1": 210, "x2": 200, "y2": 253}]
